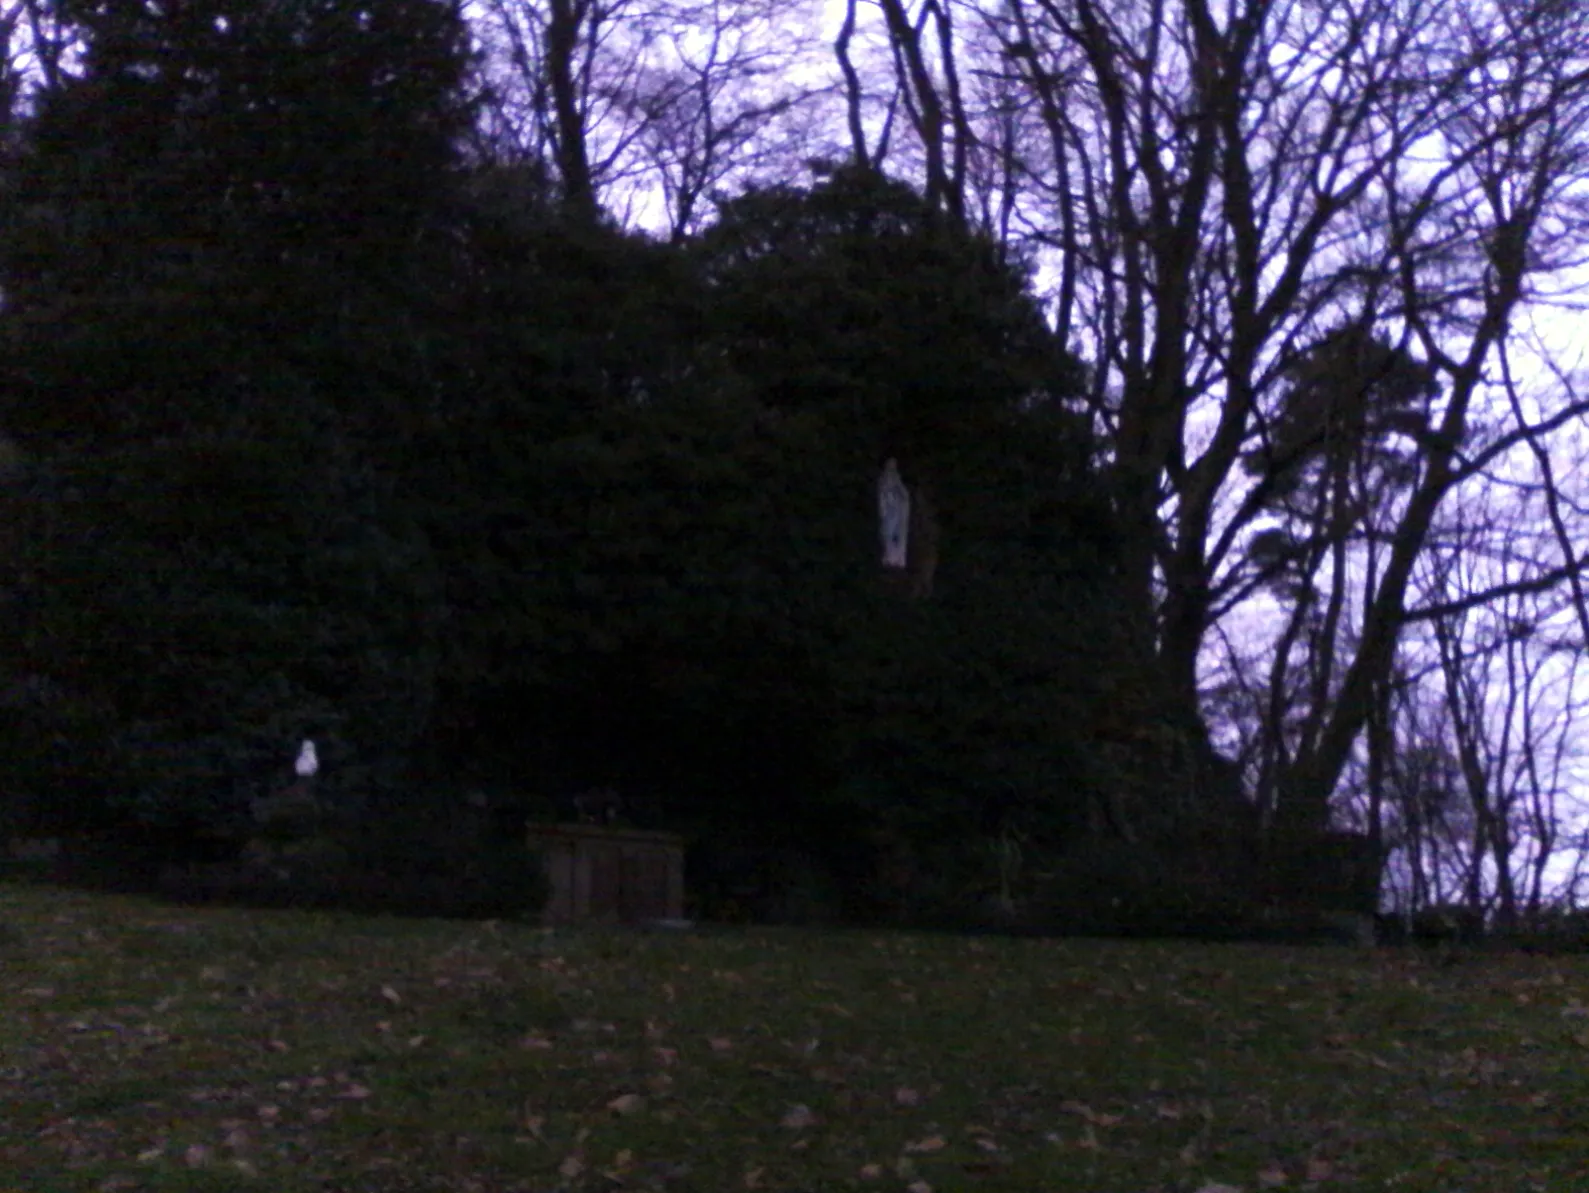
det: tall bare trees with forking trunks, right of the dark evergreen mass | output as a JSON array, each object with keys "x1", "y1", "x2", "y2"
[{"x1": 851, "y1": 0, "x2": 1589, "y2": 826}]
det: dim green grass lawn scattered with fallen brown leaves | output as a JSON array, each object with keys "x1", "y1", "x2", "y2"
[{"x1": 0, "y1": 885, "x2": 1589, "y2": 1193}]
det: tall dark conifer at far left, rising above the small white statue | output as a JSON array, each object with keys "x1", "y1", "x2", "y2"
[{"x1": 0, "y1": 0, "x2": 470, "y2": 851}]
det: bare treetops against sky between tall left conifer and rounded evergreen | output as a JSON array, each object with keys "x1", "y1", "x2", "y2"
[{"x1": 477, "y1": 0, "x2": 826, "y2": 225}]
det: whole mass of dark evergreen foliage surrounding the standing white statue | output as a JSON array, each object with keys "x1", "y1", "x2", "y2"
[{"x1": 0, "y1": 0, "x2": 1226, "y2": 913}]
